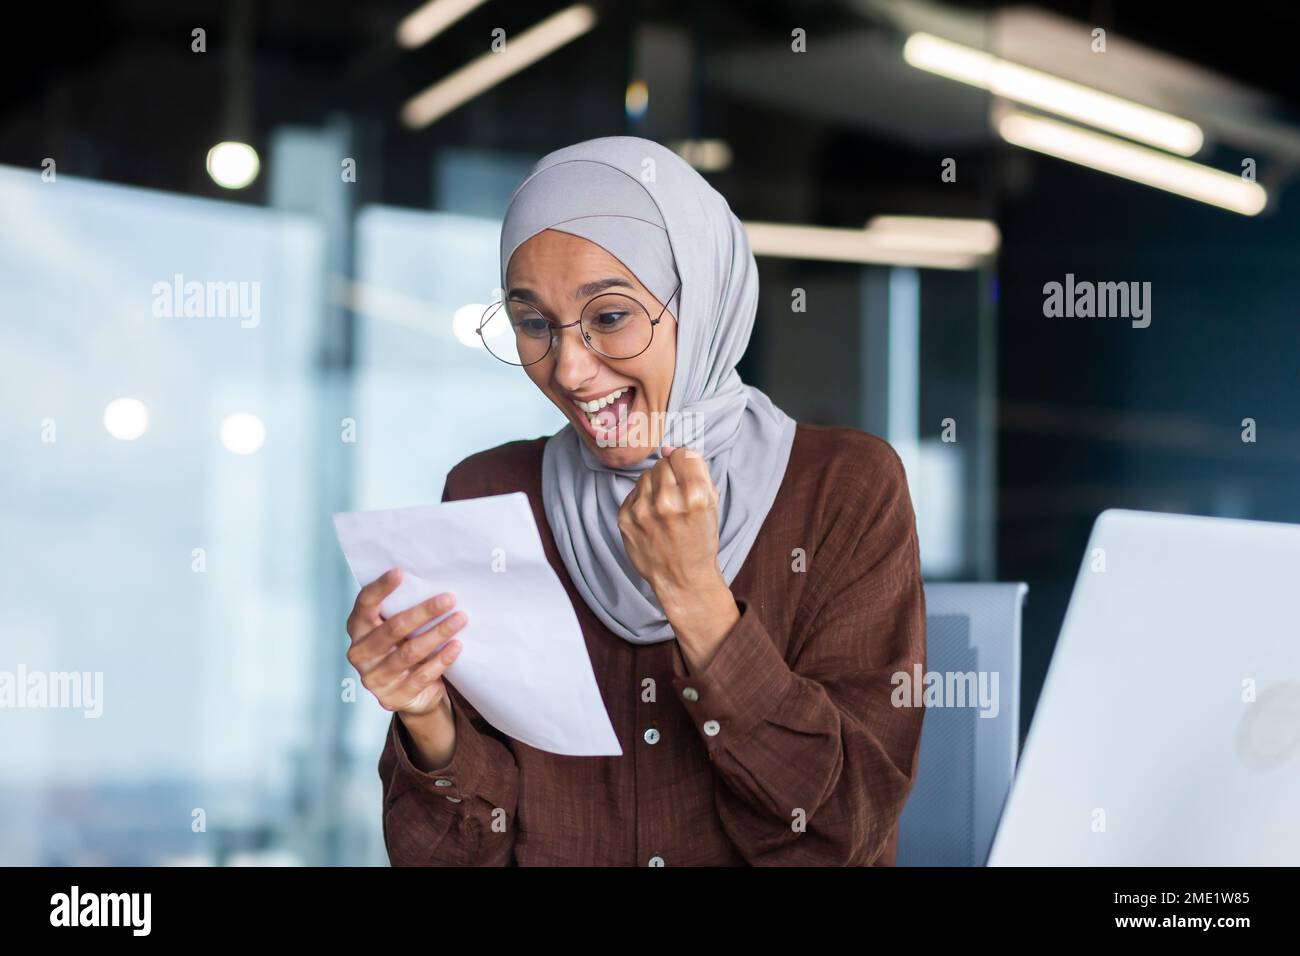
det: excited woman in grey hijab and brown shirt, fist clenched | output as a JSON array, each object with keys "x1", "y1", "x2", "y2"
[{"x1": 348, "y1": 137, "x2": 924, "y2": 866}]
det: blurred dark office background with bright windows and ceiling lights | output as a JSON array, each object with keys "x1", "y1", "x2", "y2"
[{"x1": 0, "y1": 0, "x2": 1300, "y2": 865}]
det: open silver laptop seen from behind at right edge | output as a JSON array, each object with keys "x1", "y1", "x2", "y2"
[{"x1": 988, "y1": 511, "x2": 1300, "y2": 866}]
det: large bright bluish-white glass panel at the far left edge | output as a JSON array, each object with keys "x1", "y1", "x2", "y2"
[{"x1": 0, "y1": 168, "x2": 321, "y2": 865}]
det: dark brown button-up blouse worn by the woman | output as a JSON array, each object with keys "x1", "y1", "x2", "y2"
[{"x1": 380, "y1": 425, "x2": 926, "y2": 866}]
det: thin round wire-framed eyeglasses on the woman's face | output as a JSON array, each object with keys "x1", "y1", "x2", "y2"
[{"x1": 475, "y1": 282, "x2": 681, "y2": 365}]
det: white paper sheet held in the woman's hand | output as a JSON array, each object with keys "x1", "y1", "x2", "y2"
[{"x1": 334, "y1": 492, "x2": 623, "y2": 757}]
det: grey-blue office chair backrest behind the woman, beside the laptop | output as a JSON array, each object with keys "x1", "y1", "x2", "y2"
[{"x1": 897, "y1": 583, "x2": 1028, "y2": 866}]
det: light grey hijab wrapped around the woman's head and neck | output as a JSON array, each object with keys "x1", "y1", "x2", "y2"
[{"x1": 501, "y1": 137, "x2": 794, "y2": 644}]
